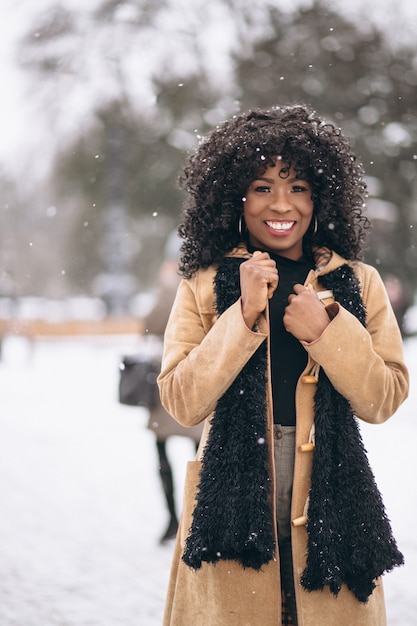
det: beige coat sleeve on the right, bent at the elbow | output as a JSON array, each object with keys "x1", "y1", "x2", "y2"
[{"x1": 303, "y1": 264, "x2": 409, "y2": 423}]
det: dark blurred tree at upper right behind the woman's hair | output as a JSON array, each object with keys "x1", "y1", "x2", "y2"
[{"x1": 231, "y1": 2, "x2": 417, "y2": 290}]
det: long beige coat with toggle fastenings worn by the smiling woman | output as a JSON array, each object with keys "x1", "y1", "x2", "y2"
[{"x1": 159, "y1": 250, "x2": 408, "y2": 626}]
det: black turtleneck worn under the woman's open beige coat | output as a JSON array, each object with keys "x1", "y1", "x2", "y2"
[{"x1": 247, "y1": 250, "x2": 311, "y2": 426}]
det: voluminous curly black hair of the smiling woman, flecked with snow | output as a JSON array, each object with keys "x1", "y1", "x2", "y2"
[{"x1": 178, "y1": 105, "x2": 369, "y2": 278}]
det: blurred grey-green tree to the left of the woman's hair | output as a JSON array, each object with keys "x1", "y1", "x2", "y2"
[{"x1": 48, "y1": 102, "x2": 182, "y2": 304}]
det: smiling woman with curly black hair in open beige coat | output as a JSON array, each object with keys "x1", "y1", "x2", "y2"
[{"x1": 159, "y1": 106, "x2": 408, "y2": 626}]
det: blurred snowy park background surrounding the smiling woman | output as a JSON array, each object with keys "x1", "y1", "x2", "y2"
[{"x1": 0, "y1": 0, "x2": 417, "y2": 626}]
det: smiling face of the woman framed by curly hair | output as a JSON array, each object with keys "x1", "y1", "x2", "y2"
[{"x1": 243, "y1": 160, "x2": 313, "y2": 261}]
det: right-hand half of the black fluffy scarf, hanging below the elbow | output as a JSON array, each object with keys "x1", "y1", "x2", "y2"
[{"x1": 301, "y1": 265, "x2": 404, "y2": 602}]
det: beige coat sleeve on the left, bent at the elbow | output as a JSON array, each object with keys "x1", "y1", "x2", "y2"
[{"x1": 158, "y1": 274, "x2": 268, "y2": 427}]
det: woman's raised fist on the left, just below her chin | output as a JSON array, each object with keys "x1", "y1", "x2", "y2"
[{"x1": 240, "y1": 250, "x2": 278, "y2": 328}]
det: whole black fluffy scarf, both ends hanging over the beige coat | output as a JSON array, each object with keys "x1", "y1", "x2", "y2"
[{"x1": 183, "y1": 257, "x2": 403, "y2": 602}]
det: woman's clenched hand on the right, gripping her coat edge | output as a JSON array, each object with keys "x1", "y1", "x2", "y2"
[{"x1": 283, "y1": 284, "x2": 330, "y2": 343}]
